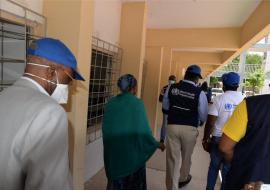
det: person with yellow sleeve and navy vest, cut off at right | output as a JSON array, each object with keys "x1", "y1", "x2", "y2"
[{"x1": 219, "y1": 91, "x2": 270, "y2": 190}]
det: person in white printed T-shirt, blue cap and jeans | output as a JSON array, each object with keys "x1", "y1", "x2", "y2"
[{"x1": 202, "y1": 72, "x2": 244, "y2": 190}]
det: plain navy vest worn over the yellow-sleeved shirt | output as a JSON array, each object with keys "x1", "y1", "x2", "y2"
[{"x1": 225, "y1": 95, "x2": 270, "y2": 190}]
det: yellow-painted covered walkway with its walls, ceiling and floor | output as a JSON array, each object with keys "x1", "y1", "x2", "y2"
[{"x1": 0, "y1": 0, "x2": 270, "y2": 190}]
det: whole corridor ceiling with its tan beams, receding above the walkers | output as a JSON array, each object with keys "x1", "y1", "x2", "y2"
[{"x1": 142, "y1": 0, "x2": 270, "y2": 78}]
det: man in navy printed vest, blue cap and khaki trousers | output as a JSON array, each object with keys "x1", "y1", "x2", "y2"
[{"x1": 163, "y1": 65, "x2": 208, "y2": 190}]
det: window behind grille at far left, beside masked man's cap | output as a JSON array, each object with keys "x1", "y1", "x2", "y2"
[{"x1": 0, "y1": 19, "x2": 33, "y2": 92}]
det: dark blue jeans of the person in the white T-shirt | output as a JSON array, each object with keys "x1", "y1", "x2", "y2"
[{"x1": 206, "y1": 137, "x2": 230, "y2": 190}]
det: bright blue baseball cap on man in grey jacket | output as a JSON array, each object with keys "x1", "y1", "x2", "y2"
[{"x1": 27, "y1": 38, "x2": 84, "y2": 81}]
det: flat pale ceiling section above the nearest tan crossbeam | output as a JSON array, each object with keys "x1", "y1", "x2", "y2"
[{"x1": 147, "y1": 0, "x2": 261, "y2": 28}]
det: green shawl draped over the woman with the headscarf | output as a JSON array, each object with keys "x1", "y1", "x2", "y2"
[{"x1": 102, "y1": 92, "x2": 159, "y2": 181}]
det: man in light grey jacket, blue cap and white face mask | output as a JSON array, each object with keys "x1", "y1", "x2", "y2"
[{"x1": 0, "y1": 38, "x2": 83, "y2": 190}]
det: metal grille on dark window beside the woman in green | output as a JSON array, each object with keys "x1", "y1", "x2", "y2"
[{"x1": 87, "y1": 37, "x2": 122, "y2": 143}]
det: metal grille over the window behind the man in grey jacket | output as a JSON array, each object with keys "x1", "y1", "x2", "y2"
[{"x1": 0, "y1": 0, "x2": 46, "y2": 94}]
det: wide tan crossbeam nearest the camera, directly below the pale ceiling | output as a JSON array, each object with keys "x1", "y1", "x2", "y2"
[{"x1": 146, "y1": 27, "x2": 241, "y2": 51}]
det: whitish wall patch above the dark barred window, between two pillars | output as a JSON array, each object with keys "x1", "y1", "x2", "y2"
[{"x1": 93, "y1": 0, "x2": 122, "y2": 45}]
